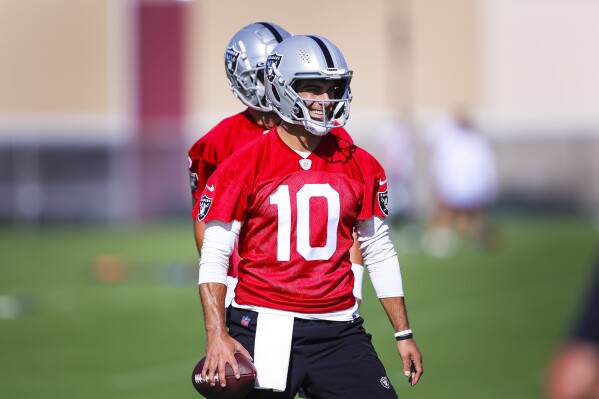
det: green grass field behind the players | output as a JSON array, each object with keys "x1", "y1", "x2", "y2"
[{"x1": 0, "y1": 216, "x2": 598, "y2": 399}]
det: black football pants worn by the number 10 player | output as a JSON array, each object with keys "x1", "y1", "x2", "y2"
[{"x1": 229, "y1": 308, "x2": 397, "y2": 399}]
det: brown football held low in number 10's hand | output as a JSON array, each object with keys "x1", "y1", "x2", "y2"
[{"x1": 191, "y1": 353, "x2": 256, "y2": 399}]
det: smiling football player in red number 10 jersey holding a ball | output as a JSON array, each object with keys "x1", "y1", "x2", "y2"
[{"x1": 198, "y1": 35, "x2": 423, "y2": 398}]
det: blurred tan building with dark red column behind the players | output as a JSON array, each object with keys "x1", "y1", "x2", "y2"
[{"x1": 0, "y1": 0, "x2": 599, "y2": 223}]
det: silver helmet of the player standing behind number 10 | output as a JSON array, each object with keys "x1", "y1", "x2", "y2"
[{"x1": 225, "y1": 22, "x2": 291, "y2": 112}]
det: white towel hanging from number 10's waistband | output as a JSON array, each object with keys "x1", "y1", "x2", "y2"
[{"x1": 254, "y1": 313, "x2": 294, "y2": 391}]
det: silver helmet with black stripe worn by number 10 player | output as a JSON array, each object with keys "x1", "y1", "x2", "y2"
[{"x1": 264, "y1": 35, "x2": 353, "y2": 136}]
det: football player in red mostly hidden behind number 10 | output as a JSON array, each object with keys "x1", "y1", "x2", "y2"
[{"x1": 188, "y1": 22, "x2": 363, "y2": 307}]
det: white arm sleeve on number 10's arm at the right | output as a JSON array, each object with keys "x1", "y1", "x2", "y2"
[{"x1": 356, "y1": 216, "x2": 404, "y2": 298}]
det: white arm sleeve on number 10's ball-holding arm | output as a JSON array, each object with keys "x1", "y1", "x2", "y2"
[{"x1": 198, "y1": 220, "x2": 241, "y2": 284}]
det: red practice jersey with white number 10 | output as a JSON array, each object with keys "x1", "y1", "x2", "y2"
[{"x1": 198, "y1": 128, "x2": 387, "y2": 313}]
